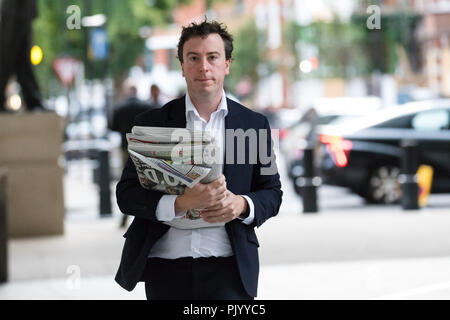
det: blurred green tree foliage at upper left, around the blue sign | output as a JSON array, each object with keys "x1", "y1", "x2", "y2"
[{"x1": 33, "y1": 0, "x2": 190, "y2": 96}]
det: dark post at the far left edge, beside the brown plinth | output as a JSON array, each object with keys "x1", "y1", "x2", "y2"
[{"x1": 0, "y1": 170, "x2": 8, "y2": 283}]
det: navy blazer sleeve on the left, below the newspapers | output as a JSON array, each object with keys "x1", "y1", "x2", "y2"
[{"x1": 116, "y1": 117, "x2": 164, "y2": 222}]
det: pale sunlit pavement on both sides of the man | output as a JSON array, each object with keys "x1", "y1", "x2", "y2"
[{"x1": 0, "y1": 160, "x2": 450, "y2": 300}]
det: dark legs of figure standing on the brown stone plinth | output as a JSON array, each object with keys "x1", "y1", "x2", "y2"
[{"x1": 0, "y1": 0, "x2": 45, "y2": 111}]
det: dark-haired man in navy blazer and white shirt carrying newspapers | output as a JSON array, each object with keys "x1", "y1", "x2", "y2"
[{"x1": 116, "y1": 21, "x2": 282, "y2": 299}]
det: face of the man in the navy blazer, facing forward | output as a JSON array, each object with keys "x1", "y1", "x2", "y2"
[{"x1": 181, "y1": 33, "x2": 231, "y2": 95}]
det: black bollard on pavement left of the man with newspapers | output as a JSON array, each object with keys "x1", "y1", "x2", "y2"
[{"x1": 98, "y1": 150, "x2": 112, "y2": 217}]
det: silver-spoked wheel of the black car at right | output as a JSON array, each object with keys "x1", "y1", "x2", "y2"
[{"x1": 367, "y1": 165, "x2": 402, "y2": 204}]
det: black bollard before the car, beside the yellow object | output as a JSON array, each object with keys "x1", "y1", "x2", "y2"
[{"x1": 399, "y1": 140, "x2": 419, "y2": 210}]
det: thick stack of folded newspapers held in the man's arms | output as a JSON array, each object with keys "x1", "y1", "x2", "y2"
[{"x1": 127, "y1": 126, "x2": 224, "y2": 229}]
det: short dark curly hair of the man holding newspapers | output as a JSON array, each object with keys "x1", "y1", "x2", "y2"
[{"x1": 177, "y1": 20, "x2": 233, "y2": 63}]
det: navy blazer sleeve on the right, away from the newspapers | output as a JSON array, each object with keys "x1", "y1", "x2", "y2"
[{"x1": 245, "y1": 119, "x2": 283, "y2": 227}]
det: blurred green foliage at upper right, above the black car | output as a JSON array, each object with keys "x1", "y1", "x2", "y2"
[{"x1": 286, "y1": 14, "x2": 420, "y2": 78}]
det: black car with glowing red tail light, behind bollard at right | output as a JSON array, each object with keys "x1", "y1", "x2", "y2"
[{"x1": 318, "y1": 100, "x2": 450, "y2": 203}]
